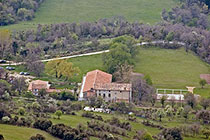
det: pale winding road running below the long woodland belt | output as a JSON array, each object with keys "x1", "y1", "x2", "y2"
[{"x1": 0, "y1": 40, "x2": 186, "y2": 66}]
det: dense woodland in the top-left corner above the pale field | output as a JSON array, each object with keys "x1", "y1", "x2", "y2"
[{"x1": 0, "y1": 0, "x2": 44, "y2": 26}]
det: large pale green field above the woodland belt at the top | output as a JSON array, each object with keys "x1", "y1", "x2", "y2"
[{"x1": 4, "y1": 0, "x2": 177, "y2": 30}]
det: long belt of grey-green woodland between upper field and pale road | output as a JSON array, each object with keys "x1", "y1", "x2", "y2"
[{"x1": 0, "y1": 18, "x2": 210, "y2": 63}]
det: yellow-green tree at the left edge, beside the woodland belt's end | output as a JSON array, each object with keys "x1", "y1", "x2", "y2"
[{"x1": 0, "y1": 29, "x2": 11, "y2": 59}]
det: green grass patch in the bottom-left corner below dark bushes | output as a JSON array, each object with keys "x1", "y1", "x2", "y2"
[{"x1": 0, "y1": 124, "x2": 58, "y2": 140}]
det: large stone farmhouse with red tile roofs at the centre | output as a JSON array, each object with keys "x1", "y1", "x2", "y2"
[{"x1": 79, "y1": 70, "x2": 132, "y2": 102}]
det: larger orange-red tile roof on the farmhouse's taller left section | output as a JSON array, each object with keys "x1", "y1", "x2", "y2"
[{"x1": 83, "y1": 70, "x2": 112, "y2": 92}]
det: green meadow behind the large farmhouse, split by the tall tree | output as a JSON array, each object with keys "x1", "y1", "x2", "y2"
[{"x1": 69, "y1": 47, "x2": 210, "y2": 88}]
